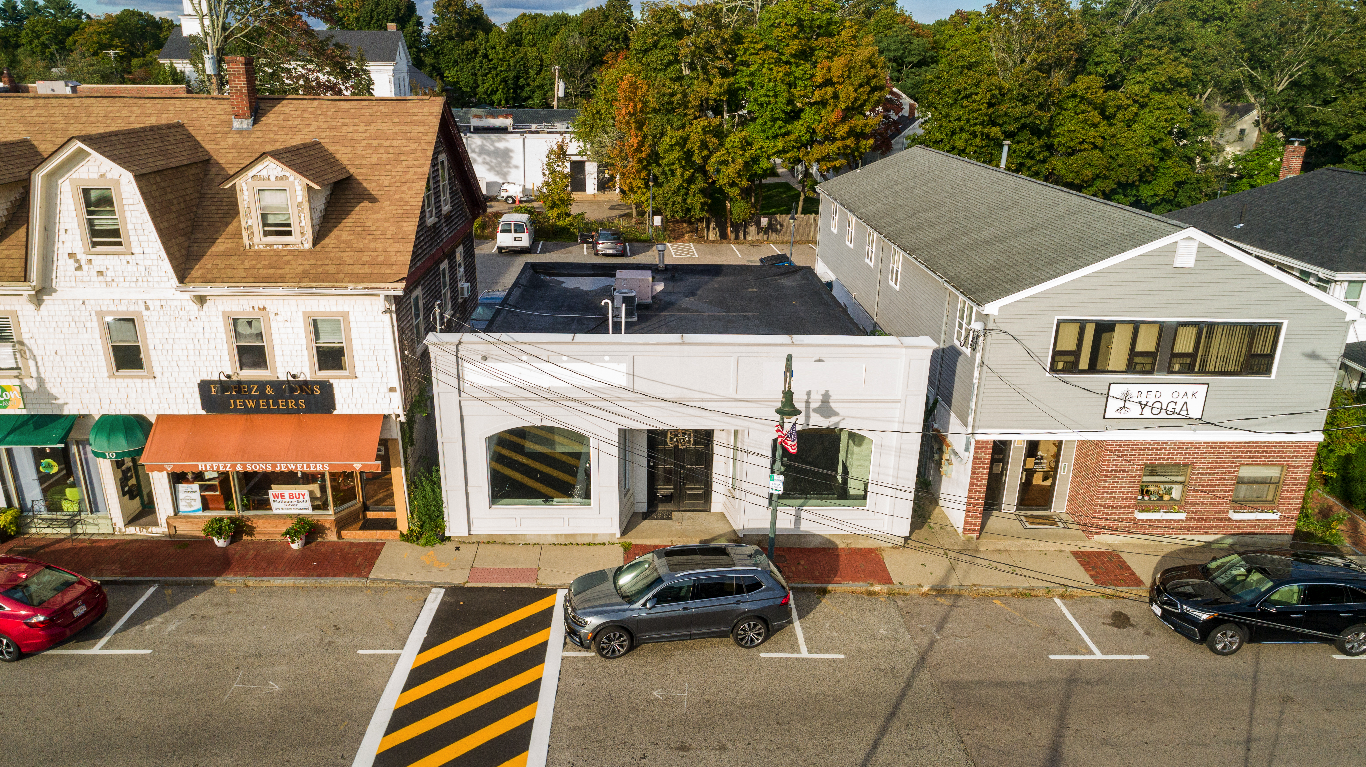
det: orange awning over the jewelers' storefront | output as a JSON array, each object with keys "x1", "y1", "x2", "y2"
[{"x1": 142, "y1": 414, "x2": 384, "y2": 472}]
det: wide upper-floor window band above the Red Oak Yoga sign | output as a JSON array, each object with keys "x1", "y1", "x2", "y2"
[{"x1": 1049, "y1": 320, "x2": 1281, "y2": 376}]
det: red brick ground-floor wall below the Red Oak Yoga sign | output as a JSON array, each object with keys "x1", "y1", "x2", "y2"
[{"x1": 1060, "y1": 440, "x2": 1318, "y2": 536}]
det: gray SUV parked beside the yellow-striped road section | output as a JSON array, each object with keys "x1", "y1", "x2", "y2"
[{"x1": 564, "y1": 544, "x2": 792, "y2": 659}]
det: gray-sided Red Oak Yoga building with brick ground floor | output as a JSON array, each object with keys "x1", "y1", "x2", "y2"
[{"x1": 817, "y1": 148, "x2": 1359, "y2": 537}]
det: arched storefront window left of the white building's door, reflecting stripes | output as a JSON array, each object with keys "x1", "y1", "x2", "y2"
[{"x1": 488, "y1": 427, "x2": 593, "y2": 506}]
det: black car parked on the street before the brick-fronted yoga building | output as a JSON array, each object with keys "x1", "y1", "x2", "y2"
[{"x1": 1147, "y1": 551, "x2": 1366, "y2": 655}]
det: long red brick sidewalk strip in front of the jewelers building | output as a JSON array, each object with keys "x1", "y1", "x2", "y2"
[{"x1": 0, "y1": 537, "x2": 384, "y2": 578}]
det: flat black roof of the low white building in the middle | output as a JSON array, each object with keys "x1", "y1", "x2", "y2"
[{"x1": 488, "y1": 263, "x2": 866, "y2": 335}]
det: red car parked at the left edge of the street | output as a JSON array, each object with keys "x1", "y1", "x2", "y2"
[{"x1": 0, "y1": 556, "x2": 109, "y2": 663}]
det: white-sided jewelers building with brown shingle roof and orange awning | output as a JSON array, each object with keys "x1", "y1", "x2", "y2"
[{"x1": 0, "y1": 59, "x2": 484, "y2": 535}]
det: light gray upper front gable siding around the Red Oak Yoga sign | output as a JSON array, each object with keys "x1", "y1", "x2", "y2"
[{"x1": 977, "y1": 243, "x2": 1347, "y2": 435}]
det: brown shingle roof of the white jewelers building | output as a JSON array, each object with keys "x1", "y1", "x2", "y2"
[{"x1": 0, "y1": 94, "x2": 444, "y2": 284}]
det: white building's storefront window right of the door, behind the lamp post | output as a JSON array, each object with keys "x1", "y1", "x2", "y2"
[{"x1": 773, "y1": 429, "x2": 873, "y2": 506}]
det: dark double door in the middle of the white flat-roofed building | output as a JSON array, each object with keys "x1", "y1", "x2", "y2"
[{"x1": 645, "y1": 429, "x2": 712, "y2": 520}]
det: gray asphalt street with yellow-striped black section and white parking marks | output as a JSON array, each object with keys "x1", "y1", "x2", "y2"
[{"x1": 0, "y1": 585, "x2": 1366, "y2": 767}]
